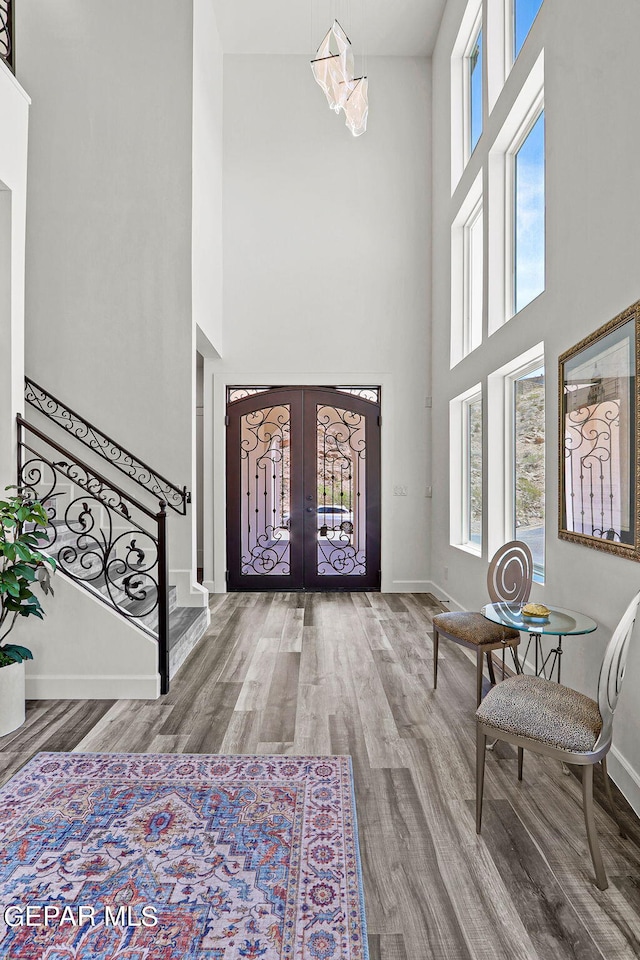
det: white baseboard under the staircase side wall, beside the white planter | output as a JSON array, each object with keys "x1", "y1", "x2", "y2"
[{"x1": 26, "y1": 674, "x2": 160, "y2": 700}]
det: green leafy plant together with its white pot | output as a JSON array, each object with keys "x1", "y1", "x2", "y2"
[{"x1": 0, "y1": 487, "x2": 55, "y2": 736}]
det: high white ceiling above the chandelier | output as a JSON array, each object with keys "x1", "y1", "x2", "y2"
[{"x1": 213, "y1": 0, "x2": 446, "y2": 57}]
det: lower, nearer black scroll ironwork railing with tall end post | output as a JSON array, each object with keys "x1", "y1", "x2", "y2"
[{"x1": 17, "y1": 415, "x2": 169, "y2": 693}]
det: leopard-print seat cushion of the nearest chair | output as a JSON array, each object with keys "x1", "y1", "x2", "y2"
[{"x1": 476, "y1": 674, "x2": 602, "y2": 753}]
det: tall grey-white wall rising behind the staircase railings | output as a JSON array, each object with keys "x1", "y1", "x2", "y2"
[{"x1": 16, "y1": 0, "x2": 195, "y2": 599}]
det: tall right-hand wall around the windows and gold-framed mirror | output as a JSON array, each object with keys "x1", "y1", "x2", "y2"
[{"x1": 432, "y1": 0, "x2": 640, "y2": 811}]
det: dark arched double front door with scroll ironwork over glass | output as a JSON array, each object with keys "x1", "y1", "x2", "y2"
[{"x1": 227, "y1": 387, "x2": 380, "y2": 590}]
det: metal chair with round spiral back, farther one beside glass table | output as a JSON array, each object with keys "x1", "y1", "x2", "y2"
[{"x1": 433, "y1": 540, "x2": 533, "y2": 706}]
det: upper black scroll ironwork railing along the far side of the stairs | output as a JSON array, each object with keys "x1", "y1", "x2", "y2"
[{"x1": 25, "y1": 377, "x2": 191, "y2": 516}]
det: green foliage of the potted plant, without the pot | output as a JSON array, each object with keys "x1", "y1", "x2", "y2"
[{"x1": 0, "y1": 487, "x2": 56, "y2": 668}]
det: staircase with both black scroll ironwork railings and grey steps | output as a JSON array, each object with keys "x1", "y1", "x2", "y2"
[{"x1": 17, "y1": 379, "x2": 209, "y2": 693}]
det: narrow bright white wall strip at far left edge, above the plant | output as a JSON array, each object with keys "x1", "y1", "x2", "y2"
[{"x1": 0, "y1": 60, "x2": 29, "y2": 493}]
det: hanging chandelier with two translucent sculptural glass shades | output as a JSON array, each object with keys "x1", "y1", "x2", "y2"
[{"x1": 311, "y1": 20, "x2": 369, "y2": 137}]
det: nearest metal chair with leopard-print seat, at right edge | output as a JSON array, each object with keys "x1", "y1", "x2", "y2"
[{"x1": 476, "y1": 593, "x2": 640, "y2": 890}]
